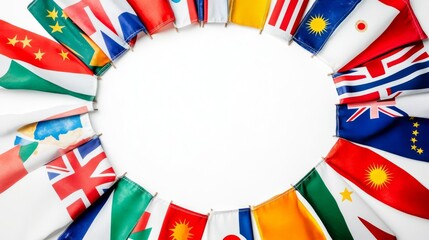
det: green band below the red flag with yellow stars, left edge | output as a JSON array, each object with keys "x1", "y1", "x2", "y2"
[{"x1": 0, "y1": 61, "x2": 95, "y2": 101}]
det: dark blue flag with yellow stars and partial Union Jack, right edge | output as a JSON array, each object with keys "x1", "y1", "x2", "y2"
[{"x1": 337, "y1": 104, "x2": 429, "y2": 162}]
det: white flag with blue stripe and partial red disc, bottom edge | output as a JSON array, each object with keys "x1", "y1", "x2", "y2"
[{"x1": 204, "y1": 208, "x2": 254, "y2": 240}]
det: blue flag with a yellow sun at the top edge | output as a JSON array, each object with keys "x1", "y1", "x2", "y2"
[{"x1": 293, "y1": 0, "x2": 361, "y2": 54}]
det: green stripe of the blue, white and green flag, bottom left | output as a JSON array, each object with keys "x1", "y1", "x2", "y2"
[{"x1": 110, "y1": 177, "x2": 153, "y2": 240}]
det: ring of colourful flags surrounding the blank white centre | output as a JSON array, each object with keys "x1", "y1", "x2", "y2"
[{"x1": 0, "y1": 0, "x2": 429, "y2": 240}]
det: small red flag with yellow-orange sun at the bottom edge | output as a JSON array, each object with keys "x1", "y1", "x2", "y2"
[{"x1": 159, "y1": 203, "x2": 207, "y2": 240}]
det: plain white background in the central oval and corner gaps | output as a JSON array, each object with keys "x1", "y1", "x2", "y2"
[{"x1": 0, "y1": 0, "x2": 429, "y2": 239}]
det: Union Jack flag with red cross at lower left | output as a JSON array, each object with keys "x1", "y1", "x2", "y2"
[{"x1": 46, "y1": 138, "x2": 116, "y2": 219}]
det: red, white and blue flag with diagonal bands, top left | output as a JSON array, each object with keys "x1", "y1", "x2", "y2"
[{"x1": 55, "y1": 0, "x2": 130, "y2": 61}]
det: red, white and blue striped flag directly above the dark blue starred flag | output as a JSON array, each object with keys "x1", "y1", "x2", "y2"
[{"x1": 333, "y1": 41, "x2": 429, "y2": 103}]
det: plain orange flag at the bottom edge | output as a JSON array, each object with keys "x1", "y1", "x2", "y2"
[{"x1": 252, "y1": 190, "x2": 327, "y2": 240}]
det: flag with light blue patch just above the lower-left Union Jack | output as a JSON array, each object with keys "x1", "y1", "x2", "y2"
[{"x1": 0, "y1": 114, "x2": 95, "y2": 193}]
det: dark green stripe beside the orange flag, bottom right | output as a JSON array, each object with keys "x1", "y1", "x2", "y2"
[{"x1": 295, "y1": 168, "x2": 353, "y2": 240}]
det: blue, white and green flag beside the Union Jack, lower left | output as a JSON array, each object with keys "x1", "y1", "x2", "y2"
[{"x1": 59, "y1": 177, "x2": 152, "y2": 240}]
